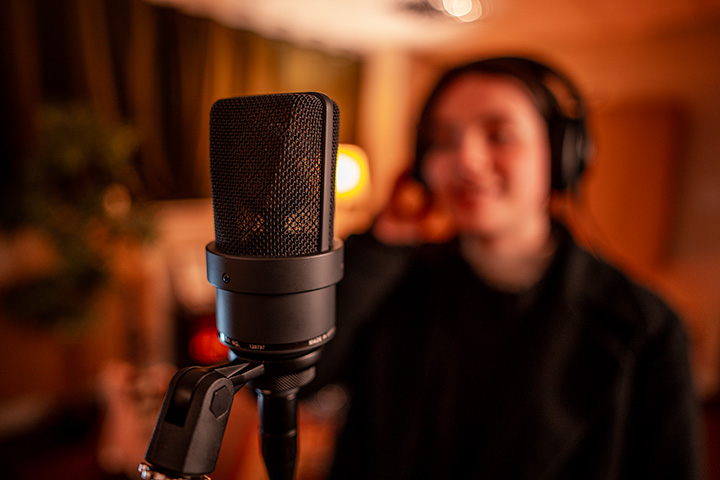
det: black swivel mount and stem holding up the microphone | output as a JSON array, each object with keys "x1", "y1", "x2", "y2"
[{"x1": 138, "y1": 349, "x2": 320, "y2": 480}]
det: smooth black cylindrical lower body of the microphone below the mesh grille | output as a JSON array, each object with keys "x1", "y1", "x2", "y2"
[{"x1": 206, "y1": 242, "x2": 343, "y2": 360}]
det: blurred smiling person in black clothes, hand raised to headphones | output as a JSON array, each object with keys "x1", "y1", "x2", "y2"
[{"x1": 310, "y1": 57, "x2": 702, "y2": 479}]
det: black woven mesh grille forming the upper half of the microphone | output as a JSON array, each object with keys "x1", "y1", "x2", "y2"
[{"x1": 210, "y1": 93, "x2": 339, "y2": 257}]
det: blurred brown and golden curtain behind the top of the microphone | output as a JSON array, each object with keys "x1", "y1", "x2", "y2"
[{"x1": 0, "y1": 0, "x2": 361, "y2": 199}]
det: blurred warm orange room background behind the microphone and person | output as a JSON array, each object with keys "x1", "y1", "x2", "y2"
[{"x1": 0, "y1": 0, "x2": 720, "y2": 480}]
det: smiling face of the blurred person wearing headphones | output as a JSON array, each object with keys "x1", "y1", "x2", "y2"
[{"x1": 422, "y1": 73, "x2": 550, "y2": 236}]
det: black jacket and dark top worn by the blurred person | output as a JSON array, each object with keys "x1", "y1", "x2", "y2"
[{"x1": 318, "y1": 228, "x2": 701, "y2": 480}]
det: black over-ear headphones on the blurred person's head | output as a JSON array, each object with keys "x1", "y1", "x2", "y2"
[{"x1": 413, "y1": 57, "x2": 592, "y2": 192}]
